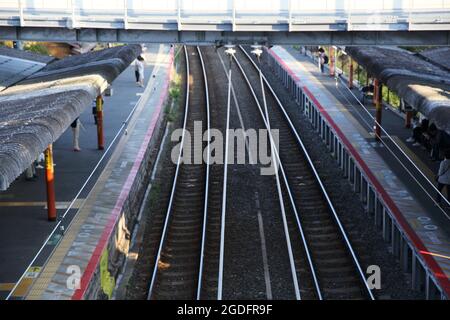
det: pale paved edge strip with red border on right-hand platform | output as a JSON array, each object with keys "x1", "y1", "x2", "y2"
[{"x1": 270, "y1": 46, "x2": 450, "y2": 295}]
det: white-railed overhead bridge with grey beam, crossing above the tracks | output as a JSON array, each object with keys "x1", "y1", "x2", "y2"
[{"x1": 0, "y1": 0, "x2": 450, "y2": 45}]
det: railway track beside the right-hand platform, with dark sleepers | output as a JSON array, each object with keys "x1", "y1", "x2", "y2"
[{"x1": 235, "y1": 47, "x2": 373, "y2": 299}]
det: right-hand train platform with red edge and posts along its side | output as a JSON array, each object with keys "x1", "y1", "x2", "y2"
[{"x1": 268, "y1": 46, "x2": 450, "y2": 298}]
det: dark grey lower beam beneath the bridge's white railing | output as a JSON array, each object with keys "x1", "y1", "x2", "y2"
[{"x1": 0, "y1": 26, "x2": 450, "y2": 46}]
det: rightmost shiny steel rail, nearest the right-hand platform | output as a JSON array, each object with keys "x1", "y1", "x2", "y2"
[{"x1": 239, "y1": 46, "x2": 375, "y2": 300}]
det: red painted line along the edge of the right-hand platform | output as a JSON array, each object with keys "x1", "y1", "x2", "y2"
[{"x1": 268, "y1": 50, "x2": 450, "y2": 297}]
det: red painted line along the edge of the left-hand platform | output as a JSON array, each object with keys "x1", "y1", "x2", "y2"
[{"x1": 72, "y1": 47, "x2": 174, "y2": 300}]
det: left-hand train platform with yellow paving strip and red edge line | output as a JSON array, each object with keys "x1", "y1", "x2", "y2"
[{"x1": 0, "y1": 45, "x2": 173, "y2": 299}]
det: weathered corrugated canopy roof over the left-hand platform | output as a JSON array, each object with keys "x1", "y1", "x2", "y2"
[{"x1": 0, "y1": 45, "x2": 141, "y2": 190}]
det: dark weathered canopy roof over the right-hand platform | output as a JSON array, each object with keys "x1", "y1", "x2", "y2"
[{"x1": 345, "y1": 46, "x2": 450, "y2": 134}]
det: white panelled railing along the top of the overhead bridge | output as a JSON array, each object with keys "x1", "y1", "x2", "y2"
[{"x1": 0, "y1": 0, "x2": 450, "y2": 31}]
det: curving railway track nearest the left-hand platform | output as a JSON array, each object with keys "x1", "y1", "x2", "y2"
[{"x1": 148, "y1": 47, "x2": 209, "y2": 299}]
